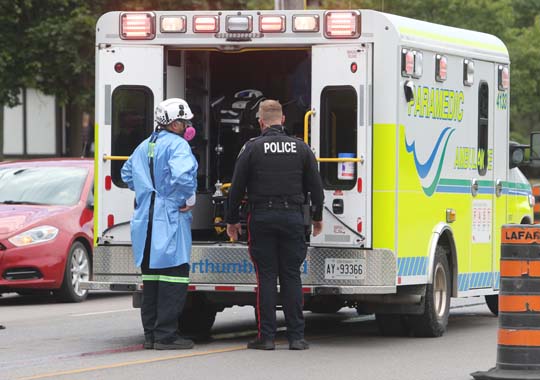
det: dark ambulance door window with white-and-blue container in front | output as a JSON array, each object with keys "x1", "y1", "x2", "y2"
[{"x1": 321, "y1": 86, "x2": 358, "y2": 190}]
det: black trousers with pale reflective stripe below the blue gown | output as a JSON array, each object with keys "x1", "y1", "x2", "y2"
[{"x1": 141, "y1": 227, "x2": 189, "y2": 343}]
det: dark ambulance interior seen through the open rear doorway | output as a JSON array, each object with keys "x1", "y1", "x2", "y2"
[{"x1": 167, "y1": 49, "x2": 311, "y2": 241}]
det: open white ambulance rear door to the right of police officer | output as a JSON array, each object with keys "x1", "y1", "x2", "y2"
[{"x1": 311, "y1": 44, "x2": 372, "y2": 248}]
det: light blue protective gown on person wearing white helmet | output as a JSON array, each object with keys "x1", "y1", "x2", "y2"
[{"x1": 122, "y1": 131, "x2": 198, "y2": 269}]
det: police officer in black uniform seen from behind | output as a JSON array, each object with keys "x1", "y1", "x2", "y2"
[{"x1": 227, "y1": 100, "x2": 323, "y2": 350}]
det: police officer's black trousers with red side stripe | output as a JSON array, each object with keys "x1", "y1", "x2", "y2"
[{"x1": 248, "y1": 208, "x2": 307, "y2": 341}]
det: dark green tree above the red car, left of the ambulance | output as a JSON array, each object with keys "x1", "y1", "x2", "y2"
[{"x1": 0, "y1": 0, "x2": 97, "y2": 155}]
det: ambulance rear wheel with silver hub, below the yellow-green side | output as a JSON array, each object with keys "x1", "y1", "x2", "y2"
[{"x1": 408, "y1": 245, "x2": 451, "y2": 337}]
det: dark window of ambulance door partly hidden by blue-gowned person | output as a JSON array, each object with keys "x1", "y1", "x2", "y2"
[{"x1": 111, "y1": 86, "x2": 154, "y2": 187}]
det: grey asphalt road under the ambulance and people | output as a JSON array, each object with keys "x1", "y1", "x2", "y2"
[{"x1": 0, "y1": 292, "x2": 497, "y2": 380}]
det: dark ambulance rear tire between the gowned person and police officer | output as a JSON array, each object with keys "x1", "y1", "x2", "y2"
[{"x1": 178, "y1": 297, "x2": 217, "y2": 339}]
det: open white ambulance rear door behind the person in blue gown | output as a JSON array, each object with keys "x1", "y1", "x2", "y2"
[{"x1": 95, "y1": 45, "x2": 163, "y2": 244}]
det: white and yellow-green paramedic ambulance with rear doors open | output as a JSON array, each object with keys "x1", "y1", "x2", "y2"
[{"x1": 85, "y1": 10, "x2": 534, "y2": 336}]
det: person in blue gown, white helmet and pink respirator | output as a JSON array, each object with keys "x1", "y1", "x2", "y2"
[{"x1": 122, "y1": 98, "x2": 197, "y2": 350}]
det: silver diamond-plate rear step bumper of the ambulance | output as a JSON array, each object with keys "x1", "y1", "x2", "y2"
[{"x1": 92, "y1": 243, "x2": 397, "y2": 288}]
